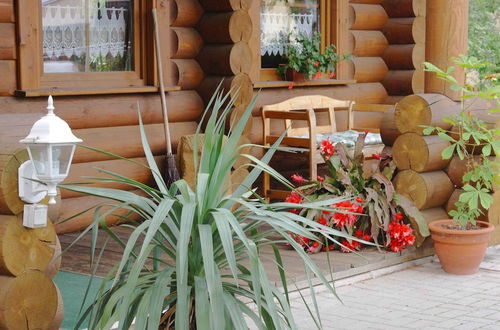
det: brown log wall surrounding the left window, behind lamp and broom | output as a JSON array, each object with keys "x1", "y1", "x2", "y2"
[{"x1": 0, "y1": 0, "x2": 204, "y2": 233}]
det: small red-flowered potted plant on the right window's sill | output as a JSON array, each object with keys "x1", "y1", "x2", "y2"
[{"x1": 278, "y1": 32, "x2": 348, "y2": 82}]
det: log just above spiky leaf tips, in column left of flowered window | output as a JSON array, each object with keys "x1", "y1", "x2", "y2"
[{"x1": 198, "y1": 73, "x2": 253, "y2": 106}]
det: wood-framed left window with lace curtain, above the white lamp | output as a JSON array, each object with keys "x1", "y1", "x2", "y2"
[{"x1": 19, "y1": 0, "x2": 158, "y2": 96}]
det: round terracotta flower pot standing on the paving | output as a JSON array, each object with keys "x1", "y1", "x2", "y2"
[{"x1": 429, "y1": 219, "x2": 494, "y2": 275}]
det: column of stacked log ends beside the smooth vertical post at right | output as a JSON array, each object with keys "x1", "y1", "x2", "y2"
[{"x1": 381, "y1": 0, "x2": 426, "y2": 104}]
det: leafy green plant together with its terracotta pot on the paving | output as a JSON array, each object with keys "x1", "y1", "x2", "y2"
[{"x1": 424, "y1": 56, "x2": 500, "y2": 275}]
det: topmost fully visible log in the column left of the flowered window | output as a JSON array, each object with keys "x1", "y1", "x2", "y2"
[{"x1": 198, "y1": 10, "x2": 252, "y2": 44}]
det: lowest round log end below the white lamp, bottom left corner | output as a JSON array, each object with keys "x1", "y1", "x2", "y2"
[{"x1": 0, "y1": 270, "x2": 57, "y2": 329}]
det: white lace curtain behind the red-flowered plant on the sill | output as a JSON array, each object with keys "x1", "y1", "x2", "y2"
[{"x1": 260, "y1": 2, "x2": 318, "y2": 56}]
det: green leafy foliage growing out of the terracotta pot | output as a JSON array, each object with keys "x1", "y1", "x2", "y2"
[{"x1": 423, "y1": 56, "x2": 500, "y2": 228}]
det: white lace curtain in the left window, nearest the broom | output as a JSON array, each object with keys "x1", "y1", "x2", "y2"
[{"x1": 42, "y1": 0, "x2": 130, "y2": 59}]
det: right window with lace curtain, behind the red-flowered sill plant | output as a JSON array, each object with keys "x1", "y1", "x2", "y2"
[{"x1": 260, "y1": 0, "x2": 348, "y2": 80}]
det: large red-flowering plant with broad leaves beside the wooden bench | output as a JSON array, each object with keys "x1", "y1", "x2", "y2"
[{"x1": 286, "y1": 133, "x2": 429, "y2": 253}]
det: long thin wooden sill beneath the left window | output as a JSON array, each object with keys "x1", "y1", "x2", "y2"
[{"x1": 15, "y1": 86, "x2": 181, "y2": 97}]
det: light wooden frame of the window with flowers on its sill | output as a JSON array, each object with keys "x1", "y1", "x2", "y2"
[{"x1": 258, "y1": 0, "x2": 349, "y2": 85}]
